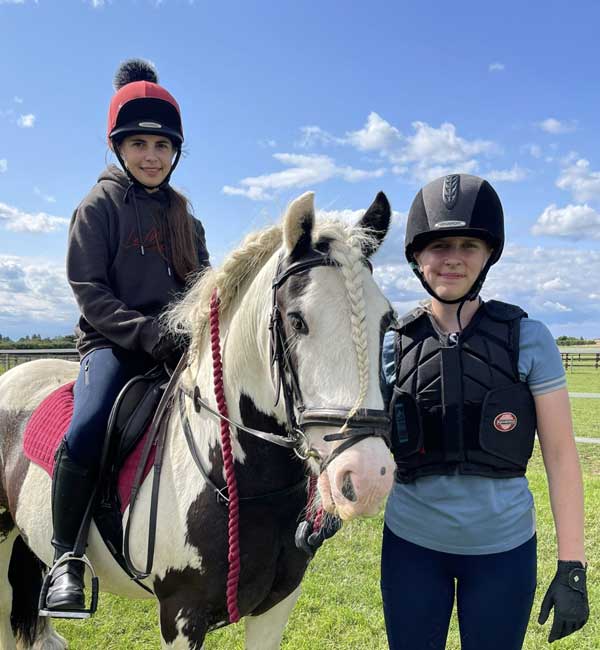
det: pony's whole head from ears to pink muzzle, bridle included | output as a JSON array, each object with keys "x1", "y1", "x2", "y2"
[{"x1": 276, "y1": 193, "x2": 393, "y2": 519}]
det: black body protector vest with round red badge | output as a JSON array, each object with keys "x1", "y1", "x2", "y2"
[{"x1": 390, "y1": 300, "x2": 536, "y2": 483}]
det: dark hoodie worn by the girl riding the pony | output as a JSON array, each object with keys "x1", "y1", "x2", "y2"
[{"x1": 67, "y1": 165, "x2": 209, "y2": 356}]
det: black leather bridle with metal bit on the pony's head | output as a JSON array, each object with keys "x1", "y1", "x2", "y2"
[{"x1": 181, "y1": 249, "x2": 391, "y2": 473}]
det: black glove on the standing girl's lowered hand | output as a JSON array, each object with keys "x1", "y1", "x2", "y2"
[{"x1": 538, "y1": 560, "x2": 590, "y2": 643}]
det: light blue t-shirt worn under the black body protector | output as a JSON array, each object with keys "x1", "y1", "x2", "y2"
[{"x1": 382, "y1": 318, "x2": 567, "y2": 555}]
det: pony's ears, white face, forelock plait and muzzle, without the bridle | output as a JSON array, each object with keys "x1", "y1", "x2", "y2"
[{"x1": 282, "y1": 193, "x2": 394, "y2": 519}]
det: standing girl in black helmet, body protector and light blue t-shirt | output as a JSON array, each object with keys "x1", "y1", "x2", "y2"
[{"x1": 381, "y1": 174, "x2": 589, "y2": 650}]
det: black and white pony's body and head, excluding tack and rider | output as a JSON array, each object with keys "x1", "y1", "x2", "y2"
[{"x1": 0, "y1": 193, "x2": 393, "y2": 650}]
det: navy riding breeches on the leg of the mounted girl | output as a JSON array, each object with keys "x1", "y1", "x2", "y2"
[{"x1": 65, "y1": 348, "x2": 155, "y2": 469}]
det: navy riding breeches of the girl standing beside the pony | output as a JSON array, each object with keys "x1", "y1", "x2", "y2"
[{"x1": 381, "y1": 526, "x2": 536, "y2": 650}]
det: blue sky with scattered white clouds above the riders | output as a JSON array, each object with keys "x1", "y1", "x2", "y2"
[{"x1": 0, "y1": 0, "x2": 600, "y2": 338}]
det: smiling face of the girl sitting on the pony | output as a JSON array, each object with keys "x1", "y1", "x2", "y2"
[{"x1": 119, "y1": 134, "x2": 176, "y2": 191}]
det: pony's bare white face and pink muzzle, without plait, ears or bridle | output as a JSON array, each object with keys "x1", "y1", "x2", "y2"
[{"x1": 294, "y1": 266, "x2": 394, "y2": 519}]
